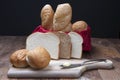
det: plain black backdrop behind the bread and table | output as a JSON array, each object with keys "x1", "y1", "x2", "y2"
[{"x1": 0, "y1": 0, "x2": 120, "y2": 38}]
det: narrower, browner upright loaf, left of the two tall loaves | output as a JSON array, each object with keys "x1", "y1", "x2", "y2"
[{"x1": 40, "y1": 4, "x2": 54, "y2": 30}]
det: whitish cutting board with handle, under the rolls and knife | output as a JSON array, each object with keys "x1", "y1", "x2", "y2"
[{"x1": 8, "y1": 59, "x2": 113, "y2": 78}]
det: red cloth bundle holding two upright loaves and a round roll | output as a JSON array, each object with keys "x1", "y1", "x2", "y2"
[{"x1": 33, "y1": 3, "x2": 91, "y2": 51}]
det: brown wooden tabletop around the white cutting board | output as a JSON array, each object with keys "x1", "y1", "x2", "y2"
[{"x1": 0, "y1": 36, "x2": 120, "y2": 80}]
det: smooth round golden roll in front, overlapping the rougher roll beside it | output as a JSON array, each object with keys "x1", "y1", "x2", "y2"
[{"x1": 26, "y1": 47, "x2": 51, "y2": 69}]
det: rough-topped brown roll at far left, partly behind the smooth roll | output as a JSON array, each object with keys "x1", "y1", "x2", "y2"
[{"x1": 10, "y1": 49, "x2": 28, "y2": 67}]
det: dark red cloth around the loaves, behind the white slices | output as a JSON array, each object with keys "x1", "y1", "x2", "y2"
[{"x1": 33, "y1": 25, "x2": 91, "y2": 51}]
